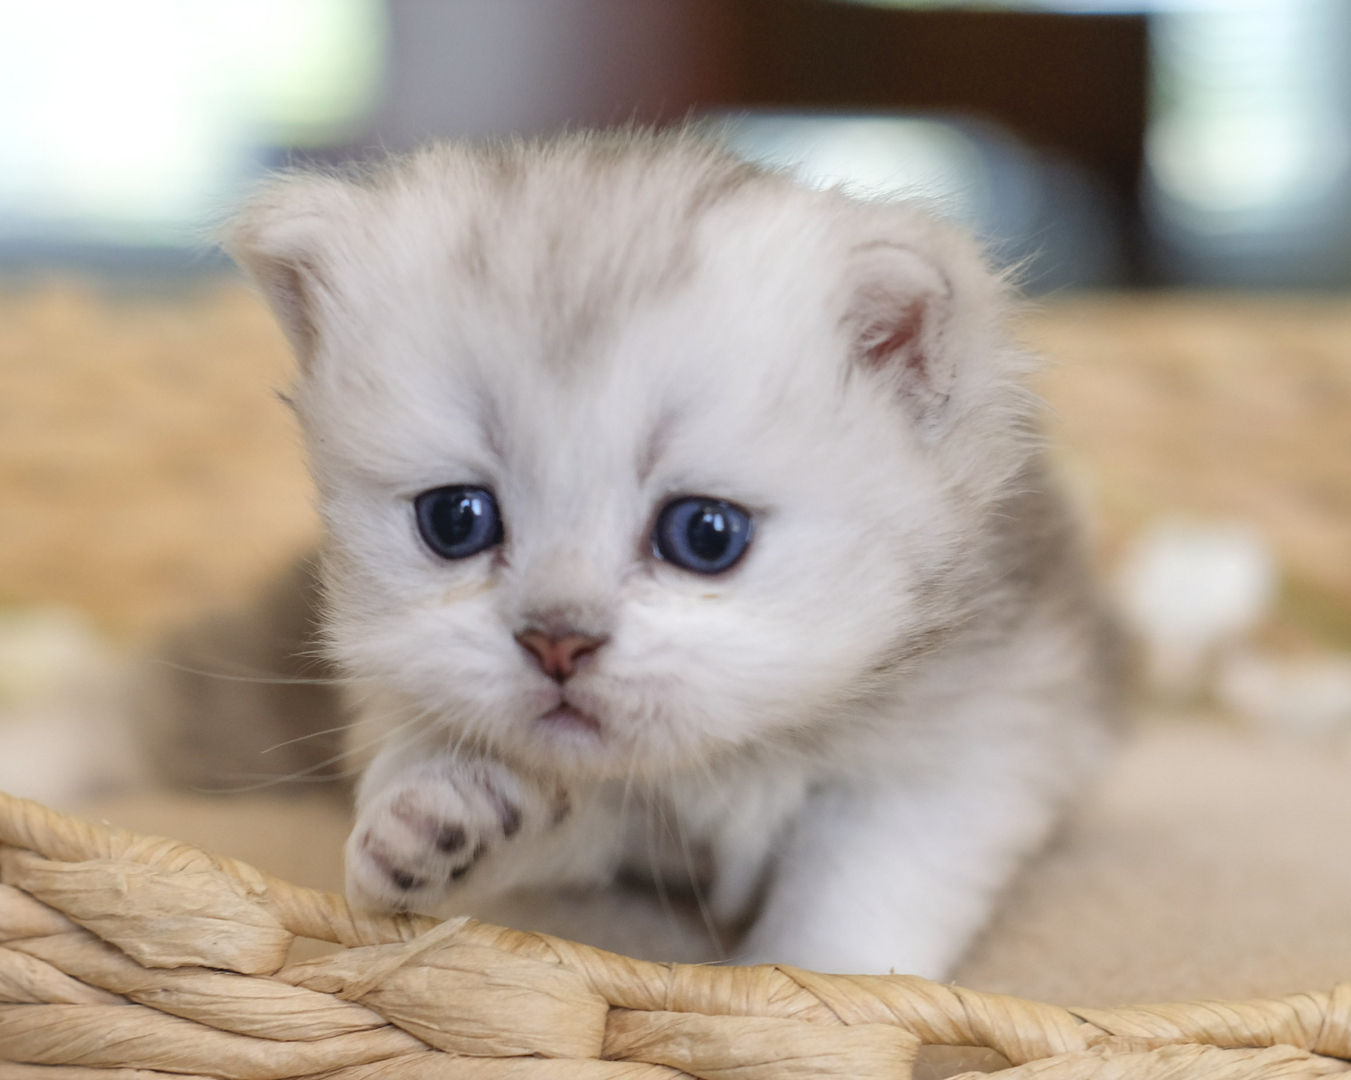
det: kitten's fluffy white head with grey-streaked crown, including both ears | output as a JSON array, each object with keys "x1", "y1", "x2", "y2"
[{"x1": 228, "y1": 134, "x2": 1029, "y2": 775}]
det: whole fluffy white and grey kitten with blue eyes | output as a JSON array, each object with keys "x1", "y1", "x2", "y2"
[{"x1": 227, "y1": 131, "x2": 1112, "y2": 977}]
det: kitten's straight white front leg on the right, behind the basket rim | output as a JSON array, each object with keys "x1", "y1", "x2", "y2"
[{"x1": 738, "y1": 746, "x2": 1056, "y2": 979}]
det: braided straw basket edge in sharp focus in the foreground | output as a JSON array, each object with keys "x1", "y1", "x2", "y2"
[{"x1": 0, "y1": 793, "x2": 1351, "y2": 1080}]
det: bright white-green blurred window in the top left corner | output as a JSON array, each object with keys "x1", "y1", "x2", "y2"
[{"x1": 0, "y1": 0, "x2": 384, "y2": 245}]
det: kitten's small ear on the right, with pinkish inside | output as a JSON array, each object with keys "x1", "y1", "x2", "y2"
[{"x1": 846, "y1": 242, "x2": 954, "y2": 414}]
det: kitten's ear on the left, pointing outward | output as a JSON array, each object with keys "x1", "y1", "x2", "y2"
[{"x1": 220, "y1": 174, "x2": 357, "y2": 372}]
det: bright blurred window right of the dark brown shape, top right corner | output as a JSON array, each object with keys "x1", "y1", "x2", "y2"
[{"x1": 1147, "y1": 0, "x2": 1351, "y2": 277}]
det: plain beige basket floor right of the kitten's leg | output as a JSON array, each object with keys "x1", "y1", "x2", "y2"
[{"x1": 958, "y1": 722, "x2": 1351, "y2": 1006}]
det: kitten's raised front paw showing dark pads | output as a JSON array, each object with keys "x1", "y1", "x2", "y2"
[{"x1": 347, "y1": 760, "x2": 567, "y2": 911}]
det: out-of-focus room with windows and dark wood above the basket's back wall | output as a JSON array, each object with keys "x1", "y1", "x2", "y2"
[{"x1": 0, "y1": 0, "x2": 1351, "y2": 291}]
